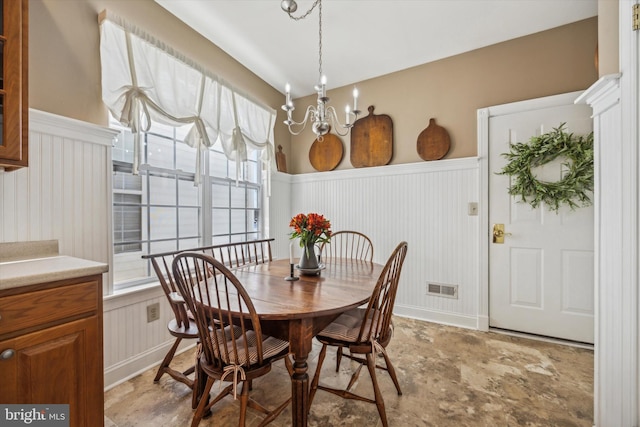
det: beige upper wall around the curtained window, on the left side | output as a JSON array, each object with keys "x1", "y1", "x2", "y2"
[{"x1": 29, "y1": 0, "x2": 290, "y2": 150}]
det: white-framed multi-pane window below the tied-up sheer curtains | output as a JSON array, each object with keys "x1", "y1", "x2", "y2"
[{"x1": 111, "y1": 119, "x2": 264, "y2": 290}]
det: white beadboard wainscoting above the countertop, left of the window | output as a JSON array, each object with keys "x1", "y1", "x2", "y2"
[{"x1": 0, "y1": 110, "x2": 115, "y2": 291}]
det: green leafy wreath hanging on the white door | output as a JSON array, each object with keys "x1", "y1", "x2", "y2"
[{"x1": 498, "y1": 123, "x2": 593, "y2": 212}]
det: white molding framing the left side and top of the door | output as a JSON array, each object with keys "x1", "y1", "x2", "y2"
[{"x1": 477, "y1": 91, "x2": 583, "y2": 331}]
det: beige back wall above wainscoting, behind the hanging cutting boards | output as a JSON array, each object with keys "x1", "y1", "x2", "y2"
[{"x1": 288, "y1": 18, "x2": 598, "y2": 173}]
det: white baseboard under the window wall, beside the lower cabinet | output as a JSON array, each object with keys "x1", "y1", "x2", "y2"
[{"x1": 104, "y1": 337, "x2": 196, "y2": 391}]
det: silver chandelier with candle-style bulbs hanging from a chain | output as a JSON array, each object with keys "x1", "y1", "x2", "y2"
[{"x1": 280, "y1": 0, "x2": 360, "y2": 141}]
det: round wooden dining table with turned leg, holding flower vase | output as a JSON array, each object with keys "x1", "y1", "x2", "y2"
[{"x1": 210, "y1": 259, "x2": 383, "y2": 427}]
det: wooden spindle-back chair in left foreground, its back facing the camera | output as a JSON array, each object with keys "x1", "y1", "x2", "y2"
[{"x1": 173, "y1": 252, "x2": 293, "y2": 427}]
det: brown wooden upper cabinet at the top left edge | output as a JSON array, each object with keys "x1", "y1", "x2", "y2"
[{"x1": 0, "y1": 0, "x2": 29, "y2": 170}]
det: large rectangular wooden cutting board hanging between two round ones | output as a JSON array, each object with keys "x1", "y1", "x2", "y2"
[{"x1": 351, "y1": 105, "x2": 393, "y2": 168}]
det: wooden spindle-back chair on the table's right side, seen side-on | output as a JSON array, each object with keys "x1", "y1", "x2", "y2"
[{"x1": 308, "y1": 242, "x2": 407, "y2": 427}]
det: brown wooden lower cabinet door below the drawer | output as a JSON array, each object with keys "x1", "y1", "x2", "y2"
[{"x1": 0, "y1": 316, "x2": 104, "y2": 427}]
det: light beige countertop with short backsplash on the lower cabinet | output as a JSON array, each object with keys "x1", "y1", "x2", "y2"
[{"x1": 0, "y1": 241, "x2": 109, "y2": 291}]
